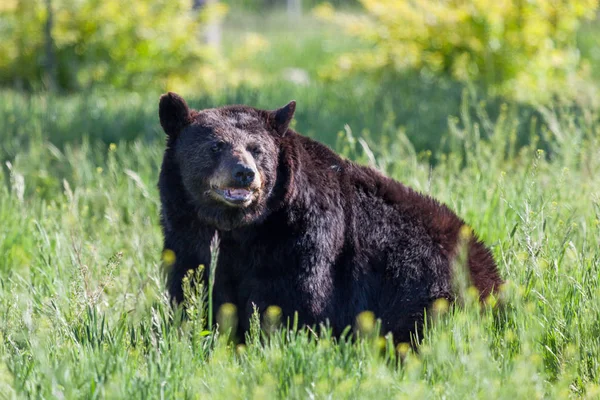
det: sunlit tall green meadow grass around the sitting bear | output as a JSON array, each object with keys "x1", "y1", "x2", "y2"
[{"x1": 0, "y1": 91, "x2": 600, "y2": 399}]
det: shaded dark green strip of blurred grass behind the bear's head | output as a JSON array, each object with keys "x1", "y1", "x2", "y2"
[{"x1": 0, "y1": 76, "x2": 537, "y2": 156}]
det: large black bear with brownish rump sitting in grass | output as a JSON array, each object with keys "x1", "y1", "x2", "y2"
[{"x1": 158, "y1": 93, "x2": 502, "y2": 342}]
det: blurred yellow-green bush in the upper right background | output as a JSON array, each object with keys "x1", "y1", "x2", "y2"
[{"x1": 315, "y1": 0, "x2": 598, "y2": 103}]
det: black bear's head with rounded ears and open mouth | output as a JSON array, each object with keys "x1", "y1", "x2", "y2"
[{"x1": 159, "y1": 93, "x2": 296, "y2": 230}]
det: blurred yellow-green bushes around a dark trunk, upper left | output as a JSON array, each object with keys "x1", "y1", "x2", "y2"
[{"x1": 0, "y1": 0, "x2": 246, "y2": 90}]
